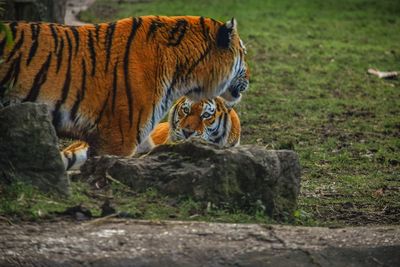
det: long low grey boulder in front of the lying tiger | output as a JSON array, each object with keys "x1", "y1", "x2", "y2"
[{"x1": 81, "y1": 142, "x2": 300, "y2": 217}]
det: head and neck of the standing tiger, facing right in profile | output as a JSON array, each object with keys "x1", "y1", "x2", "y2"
[{"x1": 166, "y1": 17, "x2": 249, "y2": 104}]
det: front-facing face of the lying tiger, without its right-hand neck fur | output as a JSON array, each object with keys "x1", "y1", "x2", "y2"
[{"x1": 170, "y1": 97, "x2": 228, "y2": 142}]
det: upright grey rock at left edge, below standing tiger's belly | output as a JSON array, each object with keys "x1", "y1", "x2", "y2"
[{"x1": 0, "y1": 103, "x2": 69, "y2": 194}]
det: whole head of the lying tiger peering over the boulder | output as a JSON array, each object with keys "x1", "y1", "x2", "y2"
[{"x1": 169, "y1": 97, "x2": 240, "y2": 147}]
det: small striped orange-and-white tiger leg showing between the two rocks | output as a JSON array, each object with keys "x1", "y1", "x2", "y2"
[{"x1": 60, "y1": 141, "x2": 89, "y2": 171}]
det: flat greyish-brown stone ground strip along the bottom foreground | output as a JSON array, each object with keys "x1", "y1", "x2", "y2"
[{"x1": 0, "y1": 219, "x2": 400, "y2": 267}]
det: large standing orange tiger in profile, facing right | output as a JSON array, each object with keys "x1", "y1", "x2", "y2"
[{"x1": 0, "y1": 16, "x2": 248, "y2": 166}]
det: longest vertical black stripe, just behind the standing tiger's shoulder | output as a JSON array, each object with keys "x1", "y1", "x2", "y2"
[{"x1": 124, "y1": 18, "x2": 142, "y2": 127}]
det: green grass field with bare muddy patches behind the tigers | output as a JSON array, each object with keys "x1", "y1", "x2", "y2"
[{"x1": 1, "y1": 0, "x2": 400, "y2": 225}]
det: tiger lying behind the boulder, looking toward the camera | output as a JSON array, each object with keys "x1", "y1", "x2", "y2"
[{"x1": 138, "y1": 96, "x2": 240, "y2": 152}]
